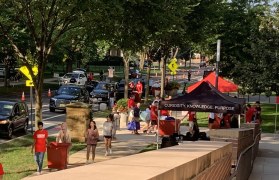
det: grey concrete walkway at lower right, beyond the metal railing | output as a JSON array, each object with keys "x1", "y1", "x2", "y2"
[{"x1": 249, "y1": 133, "x2": 279, "y2": 180}]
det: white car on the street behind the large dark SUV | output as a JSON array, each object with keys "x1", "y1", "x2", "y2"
[{"x1": 60, "y1": 71, "x2": 87, "y2": 85}]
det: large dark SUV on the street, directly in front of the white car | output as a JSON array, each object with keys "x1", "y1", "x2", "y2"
[{"x1": 49, "y1": 85, "x2": 89, "y2": 112}]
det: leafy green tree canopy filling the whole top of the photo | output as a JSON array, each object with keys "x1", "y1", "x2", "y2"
[{"x1": 0, "y1": 0, "x2": 279, "y2": 125}]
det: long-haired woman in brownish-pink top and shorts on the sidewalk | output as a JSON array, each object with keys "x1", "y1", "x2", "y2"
[{"x1": 85, "y1": 120, "x2": 99, "y2": 164}]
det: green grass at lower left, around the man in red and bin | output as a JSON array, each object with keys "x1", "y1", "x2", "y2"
[{"x1": 0, "y1": 134, "x2": 86, "y2": 180}]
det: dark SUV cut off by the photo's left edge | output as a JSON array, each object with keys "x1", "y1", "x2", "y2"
[{"x1": 0, "y1": 101, "x2": 29, "y2": 138}]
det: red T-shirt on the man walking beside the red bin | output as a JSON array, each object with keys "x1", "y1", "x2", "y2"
[{"x1": 33, "y1": 129, "x2": 48, "y2": 152}]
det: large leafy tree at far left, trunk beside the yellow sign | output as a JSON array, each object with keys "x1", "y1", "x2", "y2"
[{"x1": 0, "y1": 0, "x2": 88, "y2": 129}]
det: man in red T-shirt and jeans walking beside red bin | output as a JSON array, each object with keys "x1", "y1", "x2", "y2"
[{"x1": 31, "y1": 122, "x2": 48, "y2": 174}]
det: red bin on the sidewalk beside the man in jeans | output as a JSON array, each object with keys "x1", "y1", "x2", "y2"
[{"x1": 47, "y1": 142, "x2": 71, "y2": 170}]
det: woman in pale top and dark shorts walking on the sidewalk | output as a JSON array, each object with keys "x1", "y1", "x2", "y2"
[{"x1": 103, "y1": 115, "x2": 113, "y2": 156}]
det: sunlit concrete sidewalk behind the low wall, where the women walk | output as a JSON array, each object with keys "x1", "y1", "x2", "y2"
[{"x1": 24, "y1": 118, "x2": 160, "y2": 179}]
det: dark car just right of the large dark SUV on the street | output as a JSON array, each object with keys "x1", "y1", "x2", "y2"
[{"x1": 90, "y1": 81, "x2": 118, "y2": 103}]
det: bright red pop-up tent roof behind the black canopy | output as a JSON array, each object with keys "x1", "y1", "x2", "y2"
[{"x1": 188, "y1": 72, "x2": 238, "y2": 93}]
